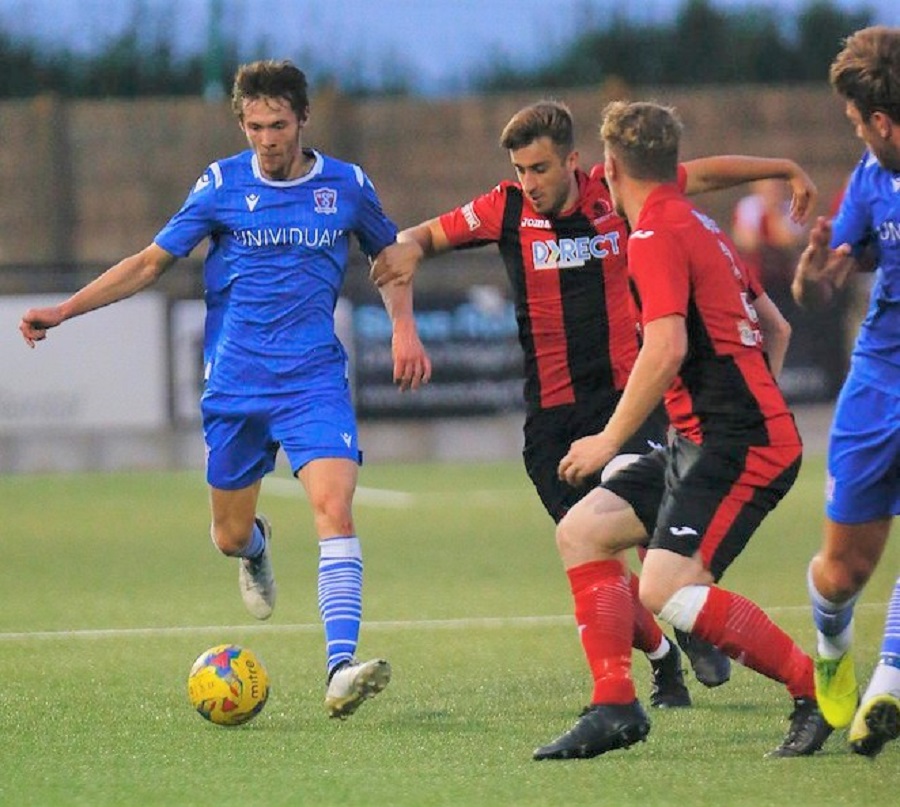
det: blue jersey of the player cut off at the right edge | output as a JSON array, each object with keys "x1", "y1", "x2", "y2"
[{"x1": 831, "y1": 152, "x2": 900, "y2": 395}]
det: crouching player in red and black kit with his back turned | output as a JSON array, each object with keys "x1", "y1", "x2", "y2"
[{"x1": 534, "y1": 102, "x2": 831, "y2": 759}]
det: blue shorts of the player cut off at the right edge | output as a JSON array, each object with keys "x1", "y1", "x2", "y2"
[{"x1": 825, "y1": 368, "x2": 900, "y2": 524}]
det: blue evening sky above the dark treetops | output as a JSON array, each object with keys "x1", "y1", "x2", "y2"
[{"x1": 0, "y1": 0, "x2": 900, "y2": 93}]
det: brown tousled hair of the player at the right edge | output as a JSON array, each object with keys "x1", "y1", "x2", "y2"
[{"x1": 828, "y1": 25, "x2": 900, "y2": 123}]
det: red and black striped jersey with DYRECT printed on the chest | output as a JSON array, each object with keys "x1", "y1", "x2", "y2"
[{"x1": 440, "y1": 165, "x2": 686, "y2": 411}]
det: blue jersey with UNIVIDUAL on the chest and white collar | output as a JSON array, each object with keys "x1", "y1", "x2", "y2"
[{"x1": 154, "y1": 150, "x2": 397, "y2": 395}]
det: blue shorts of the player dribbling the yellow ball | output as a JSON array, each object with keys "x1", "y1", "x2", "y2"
[{"x1": 200, "y1": 381, "x2": 362, "y2": 490}]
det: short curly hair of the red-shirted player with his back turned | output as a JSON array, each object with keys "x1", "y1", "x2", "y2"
[{"x1": 600, "y1": 101, "x2": 683, "y2": 182}]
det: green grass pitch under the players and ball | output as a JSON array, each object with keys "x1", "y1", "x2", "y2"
[{"x1": 0, "y1": 458, "x2": 900, "y2": 807}]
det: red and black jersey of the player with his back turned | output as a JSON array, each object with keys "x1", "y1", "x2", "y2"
[{"x1": 628, "y1": 185, "x2": 800, "y2": 445}]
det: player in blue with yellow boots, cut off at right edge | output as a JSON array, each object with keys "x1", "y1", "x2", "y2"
[{"x1": 793, "y1": 26, "x2": 900, "y2": 757}]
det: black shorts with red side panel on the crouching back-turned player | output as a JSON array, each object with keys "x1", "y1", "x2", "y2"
[{"x1": 603, "y1": 436, "x2": 802, "y2": 580}]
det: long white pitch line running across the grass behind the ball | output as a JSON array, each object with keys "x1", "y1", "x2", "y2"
[{"x1": 0, "y1": 602, "x2": 887, "y2": 642}]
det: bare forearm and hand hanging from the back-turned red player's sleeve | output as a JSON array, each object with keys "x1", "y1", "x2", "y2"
[{"x1": 558, "y1": 314, "x2": 687, "y2": 485}]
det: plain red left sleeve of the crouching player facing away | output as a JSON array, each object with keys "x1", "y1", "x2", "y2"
[{"x1": 628, "y1": 229, "x2": 690, "y2": 325}]
